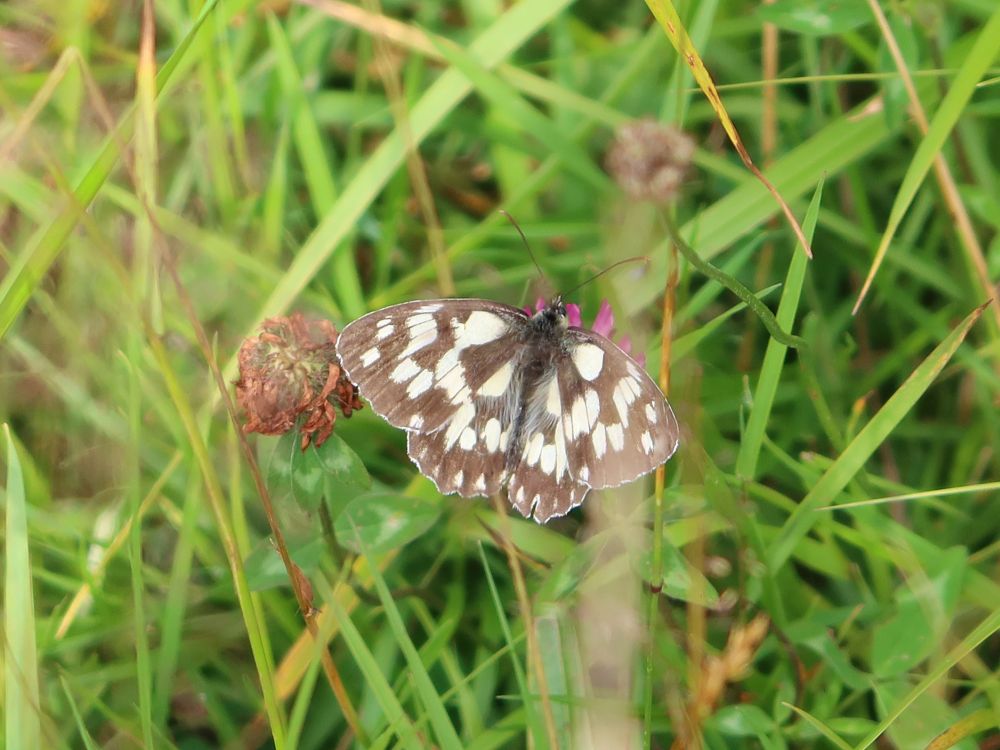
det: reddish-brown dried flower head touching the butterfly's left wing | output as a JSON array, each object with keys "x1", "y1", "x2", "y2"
[{"x1": 236, "y1": 313, "x2": 361, "y2": 450}]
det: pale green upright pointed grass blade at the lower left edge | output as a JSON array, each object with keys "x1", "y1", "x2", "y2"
[{"x1": 3, "y1": 425, "x2": 42, "y2": 748}]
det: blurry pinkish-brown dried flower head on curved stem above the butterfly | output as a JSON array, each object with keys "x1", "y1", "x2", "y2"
[{"x1": 604, "y1": 120, "x2": 694, "y2": 203}]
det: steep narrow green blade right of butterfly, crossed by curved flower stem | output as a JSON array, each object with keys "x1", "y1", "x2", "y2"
[{"x1": 736, "y1": 182, "x2": 823, "y2": 479}]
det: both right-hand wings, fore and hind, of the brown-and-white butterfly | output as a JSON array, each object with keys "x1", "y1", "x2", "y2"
[{"x1": 508, "y1": 329, "x2": 680, "y2": 523}]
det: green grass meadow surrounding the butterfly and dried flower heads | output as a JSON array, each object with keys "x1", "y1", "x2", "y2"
[{"x1": 0, "y1": 0, "x2": 1000, "y2": 750}]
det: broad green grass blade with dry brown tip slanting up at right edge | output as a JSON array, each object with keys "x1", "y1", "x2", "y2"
[{"x1": 768, "y1": 303, "x2": 990, "y2": 573}]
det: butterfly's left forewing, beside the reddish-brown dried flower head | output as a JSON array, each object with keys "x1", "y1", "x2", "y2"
[{"x1": 337, "y1": 299, "x2": 527, "y2": 432}]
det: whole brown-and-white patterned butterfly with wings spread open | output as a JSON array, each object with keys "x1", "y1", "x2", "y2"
[{"x1": 337, "y1": 297, "x2": 680, "y2": 523}]
